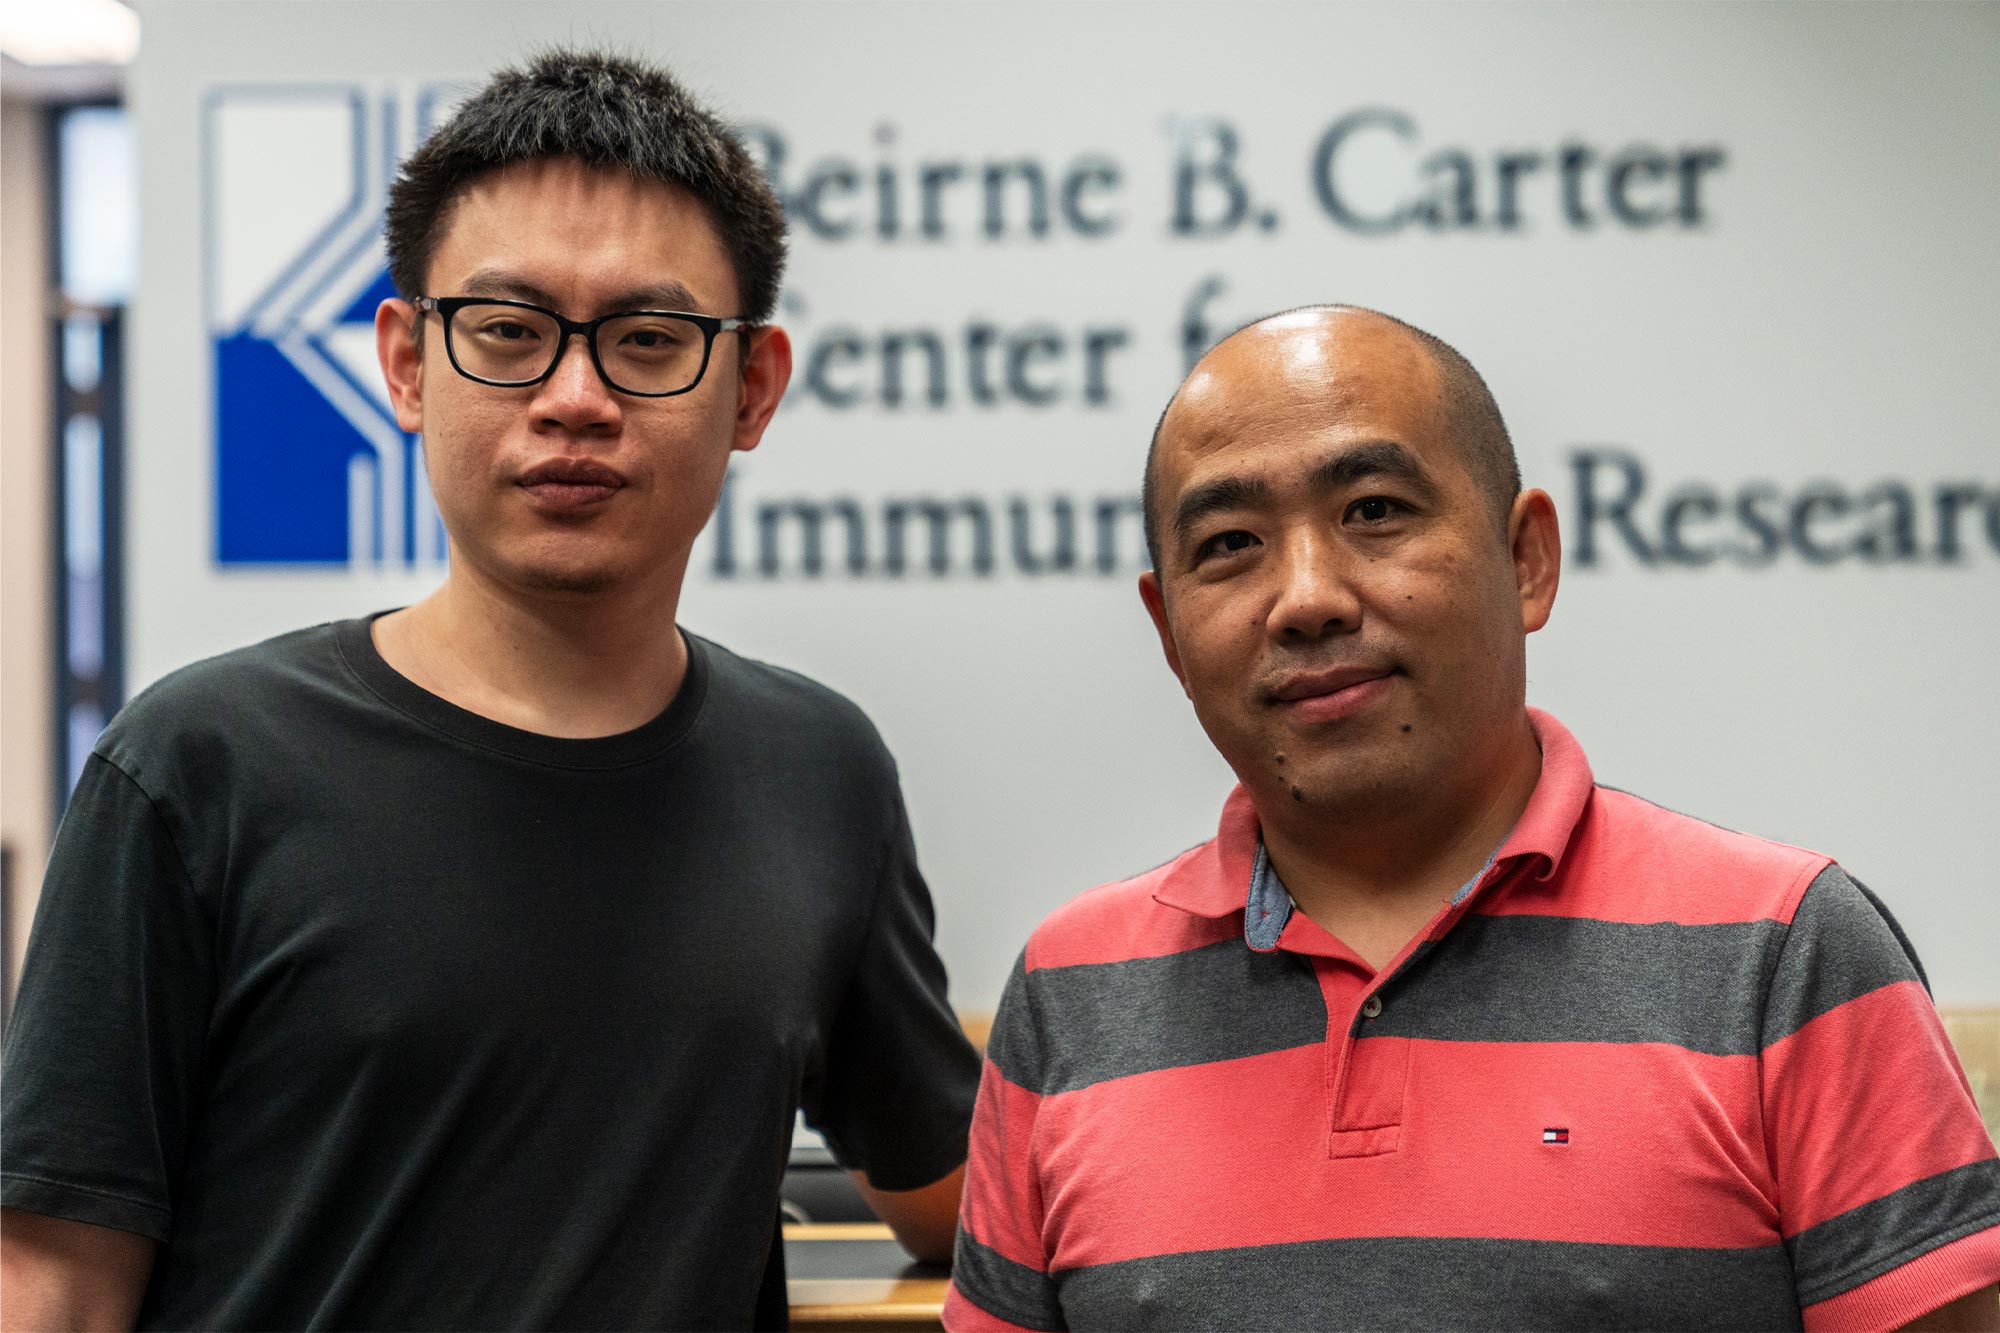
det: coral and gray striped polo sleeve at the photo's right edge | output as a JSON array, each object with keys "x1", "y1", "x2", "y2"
[{"x1": 1760, "y1": 865, "x2": 2000, "y2": 1329}]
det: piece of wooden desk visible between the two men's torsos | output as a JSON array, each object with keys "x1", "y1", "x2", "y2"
[{"x1": 784, "y1": 1223, "x2": 950, "y2": 1333}]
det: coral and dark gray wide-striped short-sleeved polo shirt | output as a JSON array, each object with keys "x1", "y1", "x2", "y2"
[{"x1": 946, "y1": 713, "x2": 2000, "y2": 1329}]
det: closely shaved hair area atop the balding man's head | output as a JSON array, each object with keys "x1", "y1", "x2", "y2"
[{"x1": 1140, "y1": 304, "x2": 1520, "y2": 568}]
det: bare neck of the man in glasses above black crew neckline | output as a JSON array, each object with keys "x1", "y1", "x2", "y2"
[{"x1": 374, "y1": 566, "x2": 688, "y2": 739}]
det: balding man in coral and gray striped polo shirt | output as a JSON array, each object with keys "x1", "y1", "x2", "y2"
[{"x1": 946, "y1": 308, "x2": 2000, "y2": 1329}]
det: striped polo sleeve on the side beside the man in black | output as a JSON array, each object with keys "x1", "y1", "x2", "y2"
[{"x1": 944, "y1": 953, "x2": 1066, "y2": 1333}]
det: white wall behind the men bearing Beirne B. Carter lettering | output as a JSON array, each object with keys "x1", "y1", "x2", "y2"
[{"x1": 128, "y1": 0, "x2": 2000, "y2": 1009}]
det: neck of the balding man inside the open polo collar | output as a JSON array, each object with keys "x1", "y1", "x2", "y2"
[{"x1": 1260, "y1": 715, "x2": 1542, "y2": 967}]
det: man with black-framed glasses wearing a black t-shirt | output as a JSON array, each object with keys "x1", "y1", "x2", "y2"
[{"x1": 0, "y1": 52, "x2": 978, "y2": 1327}]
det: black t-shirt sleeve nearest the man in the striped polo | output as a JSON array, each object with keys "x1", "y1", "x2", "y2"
[{"x1": 804, "y1": 797, "x2": 980, "y2": 1189}]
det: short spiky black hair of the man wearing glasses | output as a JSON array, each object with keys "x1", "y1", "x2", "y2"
[{"x1": 388, "y1": 48, "x2": 784, "y2": 324}]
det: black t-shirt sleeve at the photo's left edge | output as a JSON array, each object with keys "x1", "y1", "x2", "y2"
[{"x1": 0, "y1": 755, "x2": 214, "y2": 1241}]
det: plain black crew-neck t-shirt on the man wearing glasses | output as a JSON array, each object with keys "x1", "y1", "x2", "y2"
[{"x1": 0, "y1": 620, "x2": 978, "y2": 1329}]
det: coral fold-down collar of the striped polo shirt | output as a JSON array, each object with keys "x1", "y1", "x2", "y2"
[{"x1": 1152, "y1": 709, "x2": 1594, "y2": 917}]
